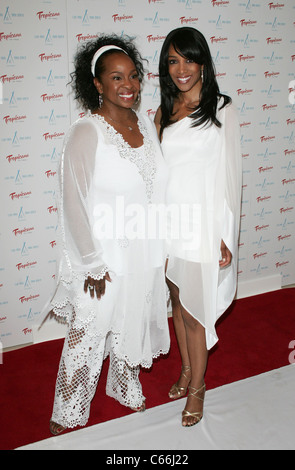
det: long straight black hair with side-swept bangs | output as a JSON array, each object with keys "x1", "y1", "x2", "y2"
[{"x1": 159, "y1": 27, "x2": 231, "y2": 134}]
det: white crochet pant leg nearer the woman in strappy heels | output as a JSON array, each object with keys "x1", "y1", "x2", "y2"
[{"x1": 106, "y1": 338, "x2": 145, "y2": 408}]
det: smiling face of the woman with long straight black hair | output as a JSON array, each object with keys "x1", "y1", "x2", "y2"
[{"x1": 168, "y1": 44, "x2": 203, "y2": 93}]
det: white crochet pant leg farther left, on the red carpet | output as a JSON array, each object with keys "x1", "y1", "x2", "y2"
[{"x1": 51, "y1": 328, "x2": 105, "y2": 428}]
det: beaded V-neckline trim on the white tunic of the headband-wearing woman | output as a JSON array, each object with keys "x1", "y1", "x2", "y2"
[{"x1": 90, "y1": 114, "x2": 156, "y2": 203}]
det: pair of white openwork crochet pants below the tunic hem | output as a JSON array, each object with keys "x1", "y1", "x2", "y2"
[{"x1": 51, "y1": 322, "x2": 144, "y2": 428}]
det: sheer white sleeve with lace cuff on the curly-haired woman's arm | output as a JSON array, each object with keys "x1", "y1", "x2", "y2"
[{"x1": 60, "y1": 120, "x2": 107, "y2": 279}]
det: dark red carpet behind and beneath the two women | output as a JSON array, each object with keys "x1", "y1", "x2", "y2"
[{"x1": 0, "y1": 288, "x2": 295, "y2": 450}]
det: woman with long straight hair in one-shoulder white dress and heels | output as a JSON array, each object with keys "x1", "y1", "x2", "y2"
[{"x1": 155, "y1": 27, "x2": 241, "y2": 427}]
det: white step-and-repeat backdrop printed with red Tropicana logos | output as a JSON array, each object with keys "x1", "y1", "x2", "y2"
[{"x1": 0, "y1": 0, "x2": 295, "y2": 347}]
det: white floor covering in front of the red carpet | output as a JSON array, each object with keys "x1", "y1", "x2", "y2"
[{"x1": 16, "y1": 365, "x2": 295, "y2": 450}]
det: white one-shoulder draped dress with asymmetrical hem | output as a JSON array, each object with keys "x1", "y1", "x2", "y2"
[{"x1": 162, "y1": 100, "x2": 242, "y2": 349}]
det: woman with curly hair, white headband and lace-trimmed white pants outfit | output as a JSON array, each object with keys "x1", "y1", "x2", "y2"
[{"x1": 50, "y1": 35, "x2": 170, "y2": 434}]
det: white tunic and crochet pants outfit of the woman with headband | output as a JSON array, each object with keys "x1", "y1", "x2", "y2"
[{"x1": 51, "y1": 114, "x2": 170, "y2": 427}]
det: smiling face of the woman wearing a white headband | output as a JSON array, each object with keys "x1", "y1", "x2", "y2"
[{"x1": 94, "y1": 52, "x2": 140, "y2": 108}]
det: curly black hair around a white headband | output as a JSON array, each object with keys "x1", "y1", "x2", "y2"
[{"x1": 70, "y1": 34, "x2": 144, "y2": 111}]
